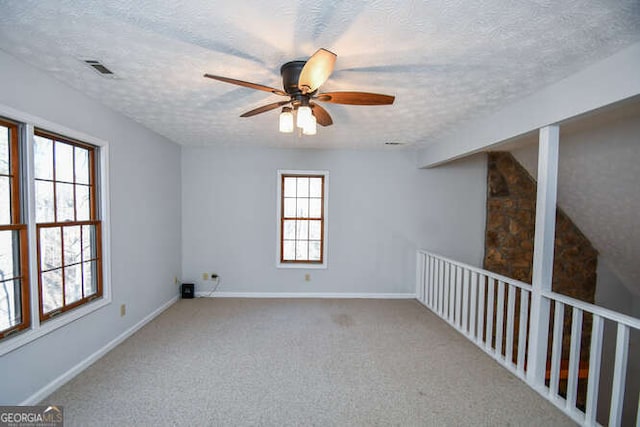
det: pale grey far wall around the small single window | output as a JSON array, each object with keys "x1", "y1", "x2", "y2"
[{"x1": 182, "y1": 147, "x2": 486, "y2": 293}]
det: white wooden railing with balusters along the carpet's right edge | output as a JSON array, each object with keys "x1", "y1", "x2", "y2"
[{"x1": 416, "y1": 250, "x2": 640, "y2": 426}]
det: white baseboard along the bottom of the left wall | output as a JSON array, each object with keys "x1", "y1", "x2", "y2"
[{"x1": 20, "y1": 295, "x2": 178, "y2": 406}]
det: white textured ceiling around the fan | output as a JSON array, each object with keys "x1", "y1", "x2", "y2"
[{"x1": 0, "y1": 0, "x2": 640, "y2": 148}]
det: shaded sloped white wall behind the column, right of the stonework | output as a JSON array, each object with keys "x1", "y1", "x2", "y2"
[{"x1": 512, "y1": 108, "x2": 640, "y2": 296}]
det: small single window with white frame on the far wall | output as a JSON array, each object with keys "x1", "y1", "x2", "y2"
[{"x1": 278, "y1": 170, "x2": 328, "y2": 267}]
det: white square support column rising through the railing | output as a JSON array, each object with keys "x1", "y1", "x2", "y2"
[{"x1": 527, "y1": 125, "x2": 560, "y2": 388}]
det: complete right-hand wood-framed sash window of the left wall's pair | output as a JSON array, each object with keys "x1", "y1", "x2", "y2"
[{"x1": 34, "y1": 130, "x2": 102, "y2": 320}]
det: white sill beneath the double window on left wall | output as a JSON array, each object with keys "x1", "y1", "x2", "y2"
[{"x1": 0, "y1": 297, "x2": 111, "y2": 356}]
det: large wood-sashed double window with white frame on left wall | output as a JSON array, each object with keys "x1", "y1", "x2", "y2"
[{"x1": 0, "y1": 113, "x2": 108, "y2": 348}]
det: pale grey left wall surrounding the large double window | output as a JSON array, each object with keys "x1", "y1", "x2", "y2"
[{"x1": 0, "y1": 52, "x2": 181, "y2": 404}]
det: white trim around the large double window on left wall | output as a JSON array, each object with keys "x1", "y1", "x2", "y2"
[{"x1": 0, "y1": 104, "x2": 112, "y2": 356}]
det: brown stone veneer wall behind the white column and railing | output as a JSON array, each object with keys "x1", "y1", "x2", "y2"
[{"x1": 484, "y1": 152, "x2": 598, "y2": 372}]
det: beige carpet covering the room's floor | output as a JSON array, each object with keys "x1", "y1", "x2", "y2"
[{"x1": 43, "y1": 298, "x2": 574, "y2": 426}]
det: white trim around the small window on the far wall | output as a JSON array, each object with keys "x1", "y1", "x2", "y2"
[{"x1": 276, "y1": 169, "x2": 329, "y2": 269}]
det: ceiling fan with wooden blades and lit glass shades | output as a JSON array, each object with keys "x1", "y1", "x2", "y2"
[{"x1": 204, "y1": 49, "x2": 395, "y2": 135}]
